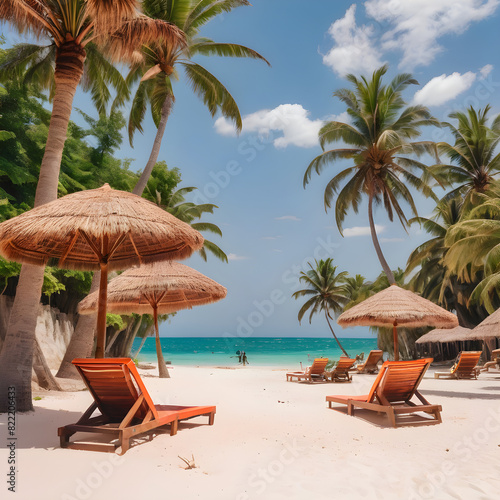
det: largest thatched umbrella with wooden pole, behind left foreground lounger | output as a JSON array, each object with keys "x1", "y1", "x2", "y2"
[{"x1": 0, "y1": 184, "x2": 203, "y2": 358}]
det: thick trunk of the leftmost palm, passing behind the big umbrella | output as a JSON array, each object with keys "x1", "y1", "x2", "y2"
[{"x1": 0, "y1": 41, "x2": 85, "y2": 412}]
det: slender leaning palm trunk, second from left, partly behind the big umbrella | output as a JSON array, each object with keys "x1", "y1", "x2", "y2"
[{"x1": 57, "y1": 94, "x2": 173, "y2": 379}]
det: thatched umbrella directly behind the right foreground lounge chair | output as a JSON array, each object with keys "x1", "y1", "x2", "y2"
[{"x1": 337, "y1": 285, "x2": 458, "y2": 361}]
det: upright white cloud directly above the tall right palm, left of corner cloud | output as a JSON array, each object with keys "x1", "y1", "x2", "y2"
[{"x1": 323, "y1": 4, "x2": 384, "y2": 76}]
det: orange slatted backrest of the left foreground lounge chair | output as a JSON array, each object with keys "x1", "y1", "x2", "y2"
[{"x1": 72, "y1": 358, "x2": 158, "y2": 421}]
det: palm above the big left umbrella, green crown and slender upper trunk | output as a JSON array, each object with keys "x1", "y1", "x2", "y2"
[{"x1": 127, "y1": 0, "x2": 269, "y2": 195}]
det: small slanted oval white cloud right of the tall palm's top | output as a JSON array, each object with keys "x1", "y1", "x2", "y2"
[{"x1": 413, "y1": 71, "x2": 476, "y2": 106}]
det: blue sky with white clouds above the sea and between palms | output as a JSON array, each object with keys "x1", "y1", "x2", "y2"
[{"x1": 5, "y1": 0, "x2": 500, "y2": 337}]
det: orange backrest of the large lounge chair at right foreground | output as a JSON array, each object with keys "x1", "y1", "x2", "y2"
[{"x1": 368, "y1": 358, "x2": 433, "y2": 403}]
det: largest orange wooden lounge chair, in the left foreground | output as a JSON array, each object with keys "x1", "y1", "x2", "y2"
[{"x1": 57, "y1": 358, "x2": 215, "y2": 455}]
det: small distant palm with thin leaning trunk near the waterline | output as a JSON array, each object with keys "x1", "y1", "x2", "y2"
[{"x1": 292, "y1": 258, "x2": 349, "y2": 357}]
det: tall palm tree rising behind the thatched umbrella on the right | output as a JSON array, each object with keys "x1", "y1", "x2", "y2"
[{"x1": 304, "y1": 66, "x2": 439, "y2": 283}]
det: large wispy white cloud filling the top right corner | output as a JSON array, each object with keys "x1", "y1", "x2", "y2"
[{"x1": 364, "y1": 0, "x2": 500, "y2": 69}]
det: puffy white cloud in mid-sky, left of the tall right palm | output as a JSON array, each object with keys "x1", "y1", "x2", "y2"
[{"x1": 214, "y1": 104, "x2": 324, "y2": 149}]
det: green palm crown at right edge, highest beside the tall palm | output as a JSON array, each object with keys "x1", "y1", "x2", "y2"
[{"x1": 433, "y1": 106, "x2": 500, "y2": 207}]
